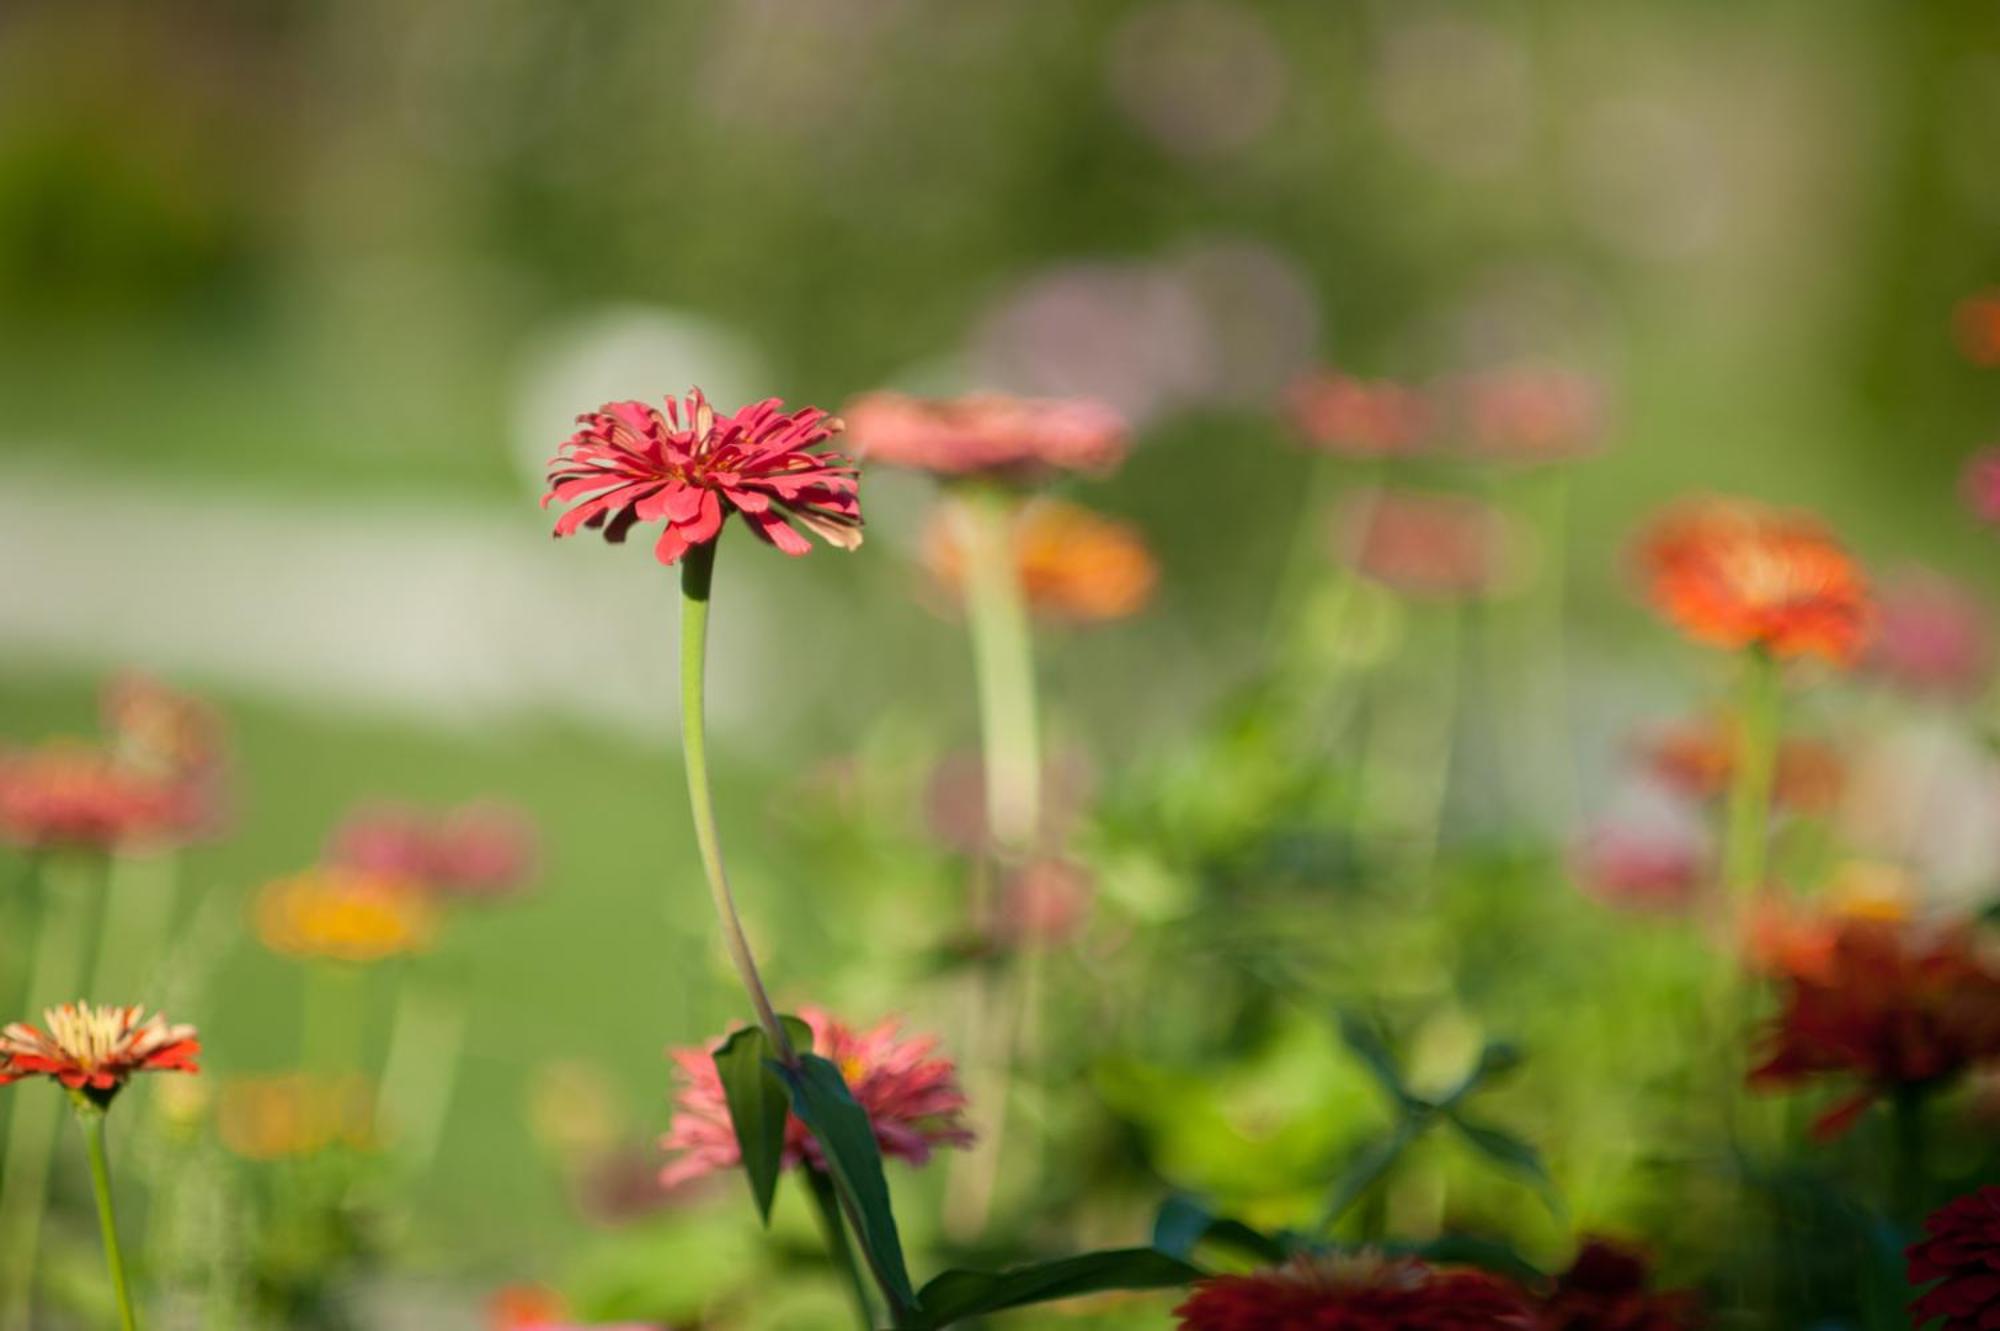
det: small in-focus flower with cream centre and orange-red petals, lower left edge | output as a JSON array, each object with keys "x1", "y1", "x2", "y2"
[{"x1": 0, "y1": 1003, "x2": 202, "y2": 1105}]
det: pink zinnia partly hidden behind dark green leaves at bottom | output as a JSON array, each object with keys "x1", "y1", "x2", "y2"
[{"x1": 660, "y1": 1007, "x2": 972, "y2": 1187}]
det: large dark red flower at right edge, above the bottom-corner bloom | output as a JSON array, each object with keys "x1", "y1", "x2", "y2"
[{"x1": 1750, "y1": 917, "x2": 2000, "y2": 1139}]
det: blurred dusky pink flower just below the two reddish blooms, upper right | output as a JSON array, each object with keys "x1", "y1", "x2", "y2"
[{"x1": 1334, "y1": 490, "x2": 1514, "y2": 600}]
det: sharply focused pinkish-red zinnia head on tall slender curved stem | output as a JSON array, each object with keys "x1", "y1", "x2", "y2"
[{"x1": 542, "y1": 388, "x2": 862, "y2": 564}]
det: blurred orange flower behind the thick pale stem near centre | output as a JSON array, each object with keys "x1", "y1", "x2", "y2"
[{"x1": 924, "y1": 500, "x2": 1160, "y2": 622}]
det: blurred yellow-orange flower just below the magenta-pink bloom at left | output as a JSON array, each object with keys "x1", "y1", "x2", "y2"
[{"x1": 256, "y1": 867, "x2": 438, "y2": 961}]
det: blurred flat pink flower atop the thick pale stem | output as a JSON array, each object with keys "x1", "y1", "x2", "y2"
[{"x1": 846, "y1": 392, "x2": 1128, "y2": 480}]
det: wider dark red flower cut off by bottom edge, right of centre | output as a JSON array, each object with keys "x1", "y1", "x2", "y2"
[{"x1": 1174, "y1": 1257, "x2": 1536, "y2": 1331}]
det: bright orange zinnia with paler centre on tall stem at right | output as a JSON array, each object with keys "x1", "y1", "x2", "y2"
[{"x1": 1638, "y1": 500, "x2": 1872, "y2": 666}]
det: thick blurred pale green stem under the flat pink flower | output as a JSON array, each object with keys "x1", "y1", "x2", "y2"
[{"x1": 958, "y1": 486, "x2": 1042, "y2": 855}]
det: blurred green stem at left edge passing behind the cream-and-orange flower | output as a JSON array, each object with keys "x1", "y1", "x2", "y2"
[{"x1": 0, "y1": 853, "x2": 94, "y2": 1331}]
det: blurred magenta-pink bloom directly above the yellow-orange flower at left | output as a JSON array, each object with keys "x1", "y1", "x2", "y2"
[{"x1": 326, "y1": 803, "x2": 536, "y2": 897}]
